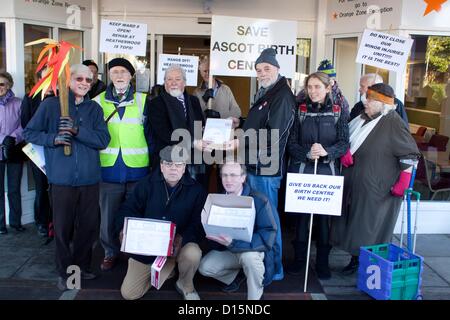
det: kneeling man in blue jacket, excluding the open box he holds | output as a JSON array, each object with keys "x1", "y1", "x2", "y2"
[{"x1": 199, "y1": 160, "x2": 279, "y2": 300}]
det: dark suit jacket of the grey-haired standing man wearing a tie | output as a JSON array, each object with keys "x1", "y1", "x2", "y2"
[{"x1": 145, "y1": 91, "x2": 205, "y2": 166}]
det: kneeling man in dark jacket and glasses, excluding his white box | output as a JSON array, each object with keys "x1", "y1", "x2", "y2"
[{"x1": 116, "y1": 146, "x2": 207, "y2": 300}]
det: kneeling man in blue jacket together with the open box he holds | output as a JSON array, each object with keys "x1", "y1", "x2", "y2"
[{"x1": 199, "y1": 161, "x2": 279, "y2": 300}]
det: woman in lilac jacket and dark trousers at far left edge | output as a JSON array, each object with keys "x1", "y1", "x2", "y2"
[{"x1": 0, "y1": 70, "x2": 25, "y2": 234}]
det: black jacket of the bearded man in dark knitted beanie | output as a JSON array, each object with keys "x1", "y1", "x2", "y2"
[{"x1": 243, "y1": 77, "x2": 295, "y2": 176}]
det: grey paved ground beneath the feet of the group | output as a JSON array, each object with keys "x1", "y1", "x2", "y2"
[{"x1": 0, "y1": 225, "x2": 450, "y2": 300}]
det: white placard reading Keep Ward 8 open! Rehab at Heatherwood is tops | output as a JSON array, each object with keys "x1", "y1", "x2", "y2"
[{"x1": 99, "y1": 19, "x2": 147, "y2": 57}]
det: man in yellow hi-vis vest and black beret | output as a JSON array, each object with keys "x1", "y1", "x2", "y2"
[{"x1": 94, "y1": 58, "x2": 149, "y2": 271}]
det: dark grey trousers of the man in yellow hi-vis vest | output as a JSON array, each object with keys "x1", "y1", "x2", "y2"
[{"x1": 100, "y1": 181, "x2": 137, "y2": 257}]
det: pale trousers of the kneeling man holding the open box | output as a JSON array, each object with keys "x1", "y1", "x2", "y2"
[{"x1": 198, "y1": 250, "x2": 265, "y2": 300}]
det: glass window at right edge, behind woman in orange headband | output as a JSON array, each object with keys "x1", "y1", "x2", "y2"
[{"x1": 405, "y1": 35, "x2": 450, "y2": 200}]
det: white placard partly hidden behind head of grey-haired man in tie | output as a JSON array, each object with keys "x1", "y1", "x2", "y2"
[{"x1": 158, "y1": 54, "x2": 198, "y2": 87}]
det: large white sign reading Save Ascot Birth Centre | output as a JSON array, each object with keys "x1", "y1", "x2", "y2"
[{"x1": 210, "y1": 16, "x2": 297, "y2": 79}]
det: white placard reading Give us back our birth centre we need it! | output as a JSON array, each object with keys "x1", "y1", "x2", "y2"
[{"x1": 285, "y1": 173, "x2": 344, "y2": 216}]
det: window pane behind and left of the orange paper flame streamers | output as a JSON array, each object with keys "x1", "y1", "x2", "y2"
[{"x1": 23, "y1": 24, "x2": 52, "y2": 92}]
